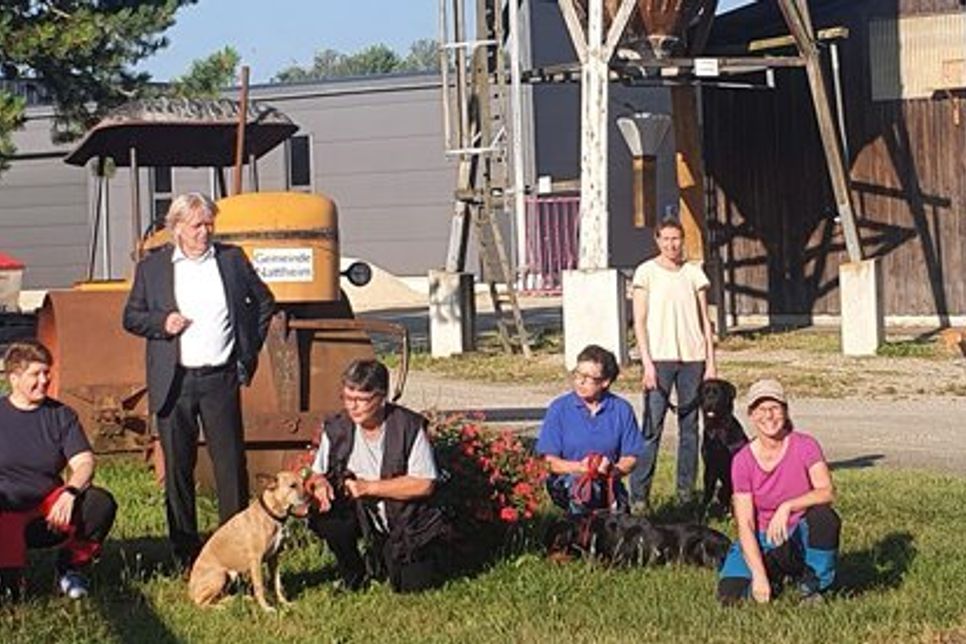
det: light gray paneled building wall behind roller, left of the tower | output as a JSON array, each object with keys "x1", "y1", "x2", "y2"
[{"x1": 0, "y1": 75, "x2": 460, "y2": 288}]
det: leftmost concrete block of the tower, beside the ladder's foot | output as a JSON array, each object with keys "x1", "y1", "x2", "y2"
[{"x1": 429, "y1": 270, "x2": 476, "y2": 358}]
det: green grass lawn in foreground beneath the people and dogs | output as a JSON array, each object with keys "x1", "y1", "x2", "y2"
[{"x1": 0, "y1": 460, "x2": 966, "y2": 643}]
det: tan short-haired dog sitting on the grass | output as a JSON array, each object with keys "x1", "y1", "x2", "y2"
[{"x1": 188, "y1": 471, "x2": 307, "y2": 611}]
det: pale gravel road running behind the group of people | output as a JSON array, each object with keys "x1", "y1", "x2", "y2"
[{"x1": 367, "y1": 298, "x2": 966, "y2": 474}]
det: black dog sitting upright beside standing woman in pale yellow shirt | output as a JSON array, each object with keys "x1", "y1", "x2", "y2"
[{"x1": 698, "y1": 378, "x2": 748, "y2": 512}]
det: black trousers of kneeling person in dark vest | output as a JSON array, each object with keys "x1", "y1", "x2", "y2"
[{"x1": 309, "y1": 502, "x2": 440, "y2": 593}]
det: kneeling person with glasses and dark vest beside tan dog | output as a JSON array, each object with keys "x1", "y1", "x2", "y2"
[{"x1": 309, "y1": 360, "x2": 447, "y2": 592}]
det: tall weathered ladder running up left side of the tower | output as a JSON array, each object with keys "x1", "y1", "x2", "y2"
[{"x1": 439, "y1": 0, "x2": 532, "y2": 358}]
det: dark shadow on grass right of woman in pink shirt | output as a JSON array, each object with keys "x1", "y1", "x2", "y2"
[{"x1": 837, "y1": 532, "x2": 917, "y2": 596}]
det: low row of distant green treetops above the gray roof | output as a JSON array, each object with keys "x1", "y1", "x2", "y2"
[{"x1": 274, "y1": 39, "x2": 439, "y2": 83}]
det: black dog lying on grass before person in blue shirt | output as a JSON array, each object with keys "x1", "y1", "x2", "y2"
[{"x1": 545, "y1": 512, "x2": 731, "y2": 568}]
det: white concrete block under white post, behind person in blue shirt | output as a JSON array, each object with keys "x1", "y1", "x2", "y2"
[{"x1": 563, "y1": 268, "x2": 627, "y2": 369}]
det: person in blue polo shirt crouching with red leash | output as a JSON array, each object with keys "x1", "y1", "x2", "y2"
[{"x1": 537, "y1": 344, "x2": 644, "y2": 515}]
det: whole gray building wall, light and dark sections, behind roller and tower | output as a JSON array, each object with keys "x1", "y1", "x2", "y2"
[{"x1": 0, "y1": 0, "x2": 677, "y2": 288}]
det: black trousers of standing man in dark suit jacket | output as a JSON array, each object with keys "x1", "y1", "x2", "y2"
[{"x1": 158, "y1": 361, "x2": 248, "y2": 563}]
